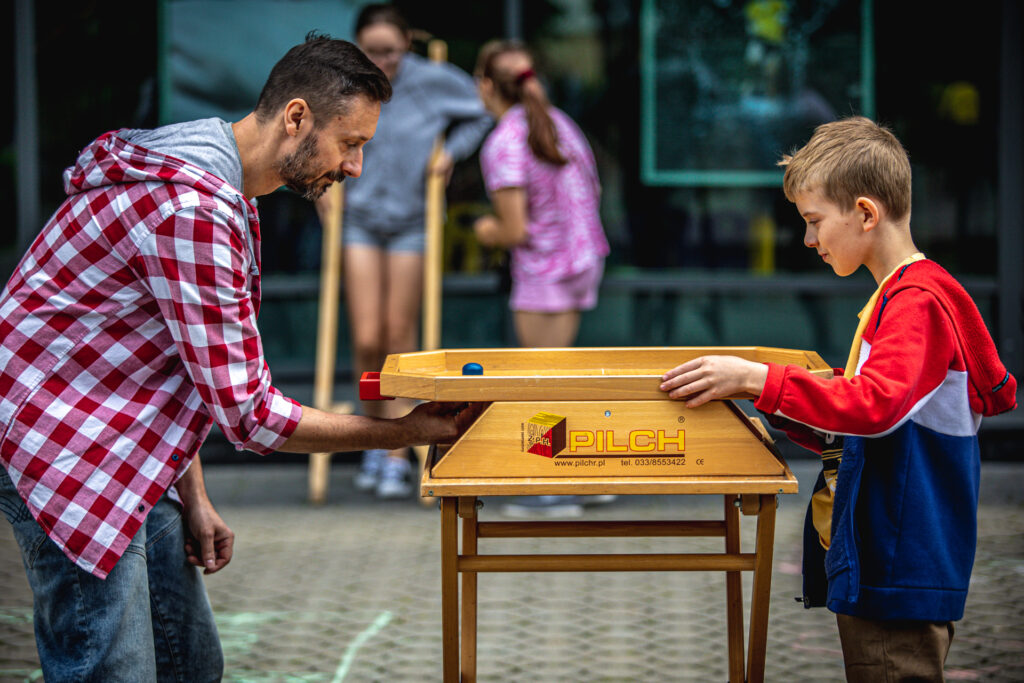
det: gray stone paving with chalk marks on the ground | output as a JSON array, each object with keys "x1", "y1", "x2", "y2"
[{"x1": 0, "y1": 461, "x2": 1024, "y2": 683}]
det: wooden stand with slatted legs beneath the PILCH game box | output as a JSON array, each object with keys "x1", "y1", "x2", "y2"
[{"x1": 423, "y1": 463, "x2": 796, "y2": 683}]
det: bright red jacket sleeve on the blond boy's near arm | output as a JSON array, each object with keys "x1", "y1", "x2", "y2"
[{"x1": 755, "y1": 289, "x2": 962, "y2": 436}]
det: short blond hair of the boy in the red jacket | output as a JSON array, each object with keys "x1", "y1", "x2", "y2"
[{"x1": 778, "y1": 116, "x2": 910, "y2": 220}]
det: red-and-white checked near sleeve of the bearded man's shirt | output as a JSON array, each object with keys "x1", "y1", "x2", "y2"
[{"x1": 136, "y1": 203, "x2": 301, "y2": 455}]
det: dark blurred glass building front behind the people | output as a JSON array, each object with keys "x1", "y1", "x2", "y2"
[{"x1": 0, "y1": 0, "x2": 1024, "y2": 458}]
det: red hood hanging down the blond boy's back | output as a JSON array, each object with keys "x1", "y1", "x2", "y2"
[{"x1": 886, "y1": 260, "x2": 1017, "y2": 417}]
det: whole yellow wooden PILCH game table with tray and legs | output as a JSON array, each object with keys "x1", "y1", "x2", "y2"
[{"x1": 360, "y1": 347, "x2": 831, "y2": 683}]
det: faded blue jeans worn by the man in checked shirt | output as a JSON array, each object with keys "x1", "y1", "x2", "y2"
[{"x1": 0, "y1": 467, "x2": 224, "y2": 683}]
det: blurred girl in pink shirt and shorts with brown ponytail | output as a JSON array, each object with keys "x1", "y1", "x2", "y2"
[{"x1": 473, "y1": 41, "x2": 608, "y2": 347}]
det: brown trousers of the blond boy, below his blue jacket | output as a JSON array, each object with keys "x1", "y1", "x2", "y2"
[{"x1": 836, "y1": 614, "x2": 953, "y2": 683}]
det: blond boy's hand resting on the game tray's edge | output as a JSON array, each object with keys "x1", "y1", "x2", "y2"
[{"x1": 659, "y1": 355, "x2": 768, "y2": 408}]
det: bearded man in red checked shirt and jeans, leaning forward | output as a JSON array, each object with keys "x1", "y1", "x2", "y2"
[{"x1": 0, "y1": 34, "x2": 474, "y2": 681}]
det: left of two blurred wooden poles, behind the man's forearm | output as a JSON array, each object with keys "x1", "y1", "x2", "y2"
[{"x1": 309, "y1": 182, "x2": 345, "y2": 504}]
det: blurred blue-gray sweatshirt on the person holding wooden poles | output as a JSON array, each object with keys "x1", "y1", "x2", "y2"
[{"x1": 345, "y1": 53, "x2": 493, "y2": 231}]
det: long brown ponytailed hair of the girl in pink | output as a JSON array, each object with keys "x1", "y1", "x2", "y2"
[{"x1": 475, "y1": 40, "x2": 568, "y2": 166}]
